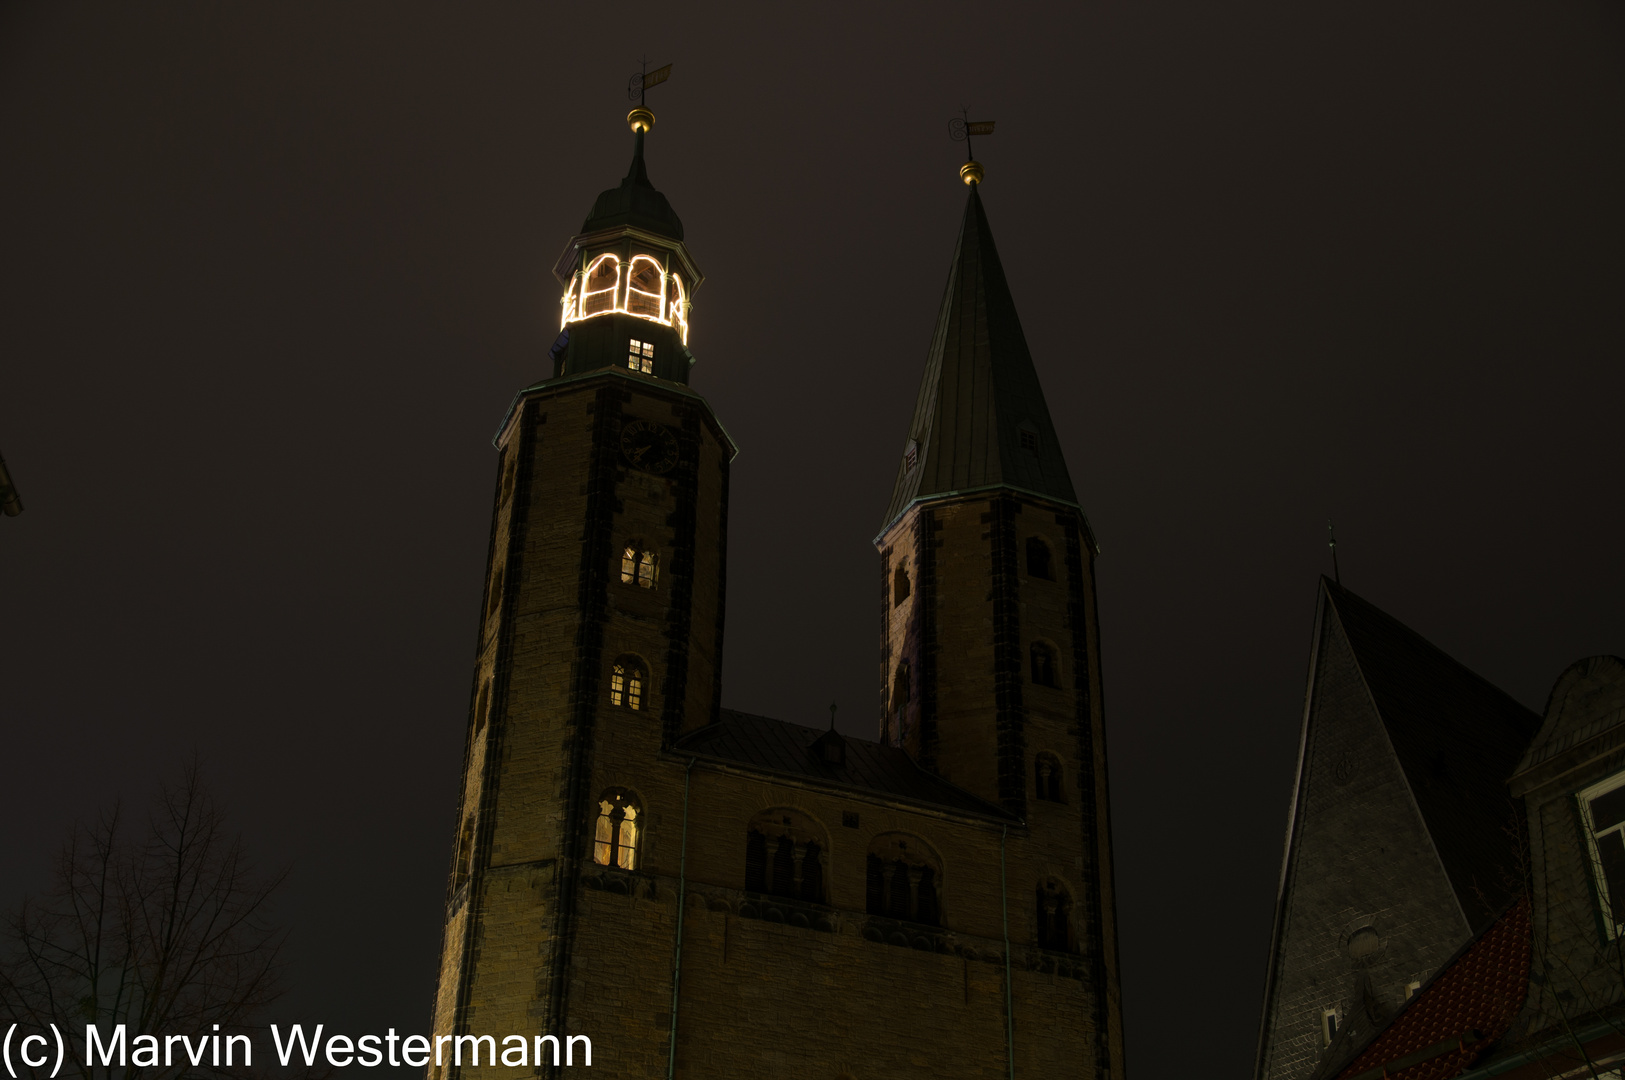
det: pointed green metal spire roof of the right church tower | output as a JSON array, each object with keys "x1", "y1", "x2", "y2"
[{"x1": 884, "y1": 185, "x2": 1077, "y2": 526}]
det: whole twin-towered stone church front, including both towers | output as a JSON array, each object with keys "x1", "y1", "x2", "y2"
[{"x1": 429, "y1": 109, "x2": 1123, "y2": 1080}]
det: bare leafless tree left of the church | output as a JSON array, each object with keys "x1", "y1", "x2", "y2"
[{"x1": 0, "y1": 762, "x2": 284, "y2": 1080}]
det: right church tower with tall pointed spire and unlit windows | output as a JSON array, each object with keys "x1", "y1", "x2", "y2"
[{"x1": 876, "y1": 162, "x2": 1120, "y2": 1072}]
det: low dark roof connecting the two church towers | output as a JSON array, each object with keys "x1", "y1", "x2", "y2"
[{"x1": 674, "y1": 708, "x2": 1016, "y2": 820}]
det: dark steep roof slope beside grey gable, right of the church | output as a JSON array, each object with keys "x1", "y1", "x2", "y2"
[{"x1": 1321, "y1": 578, "x2": 1541, "y2": 929}]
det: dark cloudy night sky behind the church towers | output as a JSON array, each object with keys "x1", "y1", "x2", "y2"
[{"x1": 0, "y1": 0, "x2": 1625, "y2": 1080}]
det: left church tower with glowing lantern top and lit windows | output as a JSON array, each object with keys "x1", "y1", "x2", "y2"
[{"x1": 431, "y1": 109, "x2": 735, "y2": 1075}]
